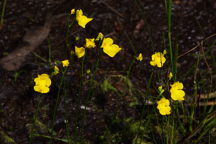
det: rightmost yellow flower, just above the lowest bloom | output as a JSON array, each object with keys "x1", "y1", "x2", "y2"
[{"x1": 170, "y1": 81, "x2": 185, "y2": 100}]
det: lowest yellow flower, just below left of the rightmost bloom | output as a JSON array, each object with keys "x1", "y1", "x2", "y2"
[{"x1": 157, "y1": 98, "x2": 171, "y2": 115}]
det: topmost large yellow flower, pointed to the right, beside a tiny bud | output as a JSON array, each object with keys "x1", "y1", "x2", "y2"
[{"x1": 76, "y1": 9, "x2": 93, "y2": 28}]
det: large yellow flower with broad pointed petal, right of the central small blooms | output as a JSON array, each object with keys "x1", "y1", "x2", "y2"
[{"x1": 101, "y1": 38, "x2": 121, "y2": 57}]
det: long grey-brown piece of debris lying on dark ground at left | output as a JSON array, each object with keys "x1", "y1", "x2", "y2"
[{"x1": 0, "y1": 14, "x2": 52, "y2": 71}]
